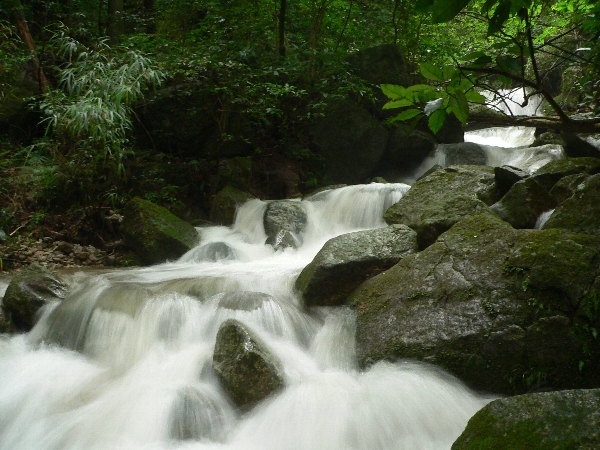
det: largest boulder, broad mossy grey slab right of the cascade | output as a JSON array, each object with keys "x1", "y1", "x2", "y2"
[{"x1": 348, "y1": 214, "x2": 600, "y2": 393}]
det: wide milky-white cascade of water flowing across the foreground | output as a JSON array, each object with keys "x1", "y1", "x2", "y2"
[{"x1": 0, "y1": 184, "x2": 490, "y2": 450}]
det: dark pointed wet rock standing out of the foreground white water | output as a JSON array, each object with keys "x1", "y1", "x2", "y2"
[{"x1": 213, "y1": 319, "x2": 284, "y2": 407}]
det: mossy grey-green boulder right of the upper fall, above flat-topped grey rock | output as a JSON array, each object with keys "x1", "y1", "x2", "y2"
[{"x1": 384, "y1": 166, "x2": 498, "y2": 248}]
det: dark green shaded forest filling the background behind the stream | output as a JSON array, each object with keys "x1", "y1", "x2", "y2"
[{"x1": 0, "y1": 0, "x2": 600, "y2": 264}]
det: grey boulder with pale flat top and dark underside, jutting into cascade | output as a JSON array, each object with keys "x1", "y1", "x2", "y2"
[{"x1": 296, "y1": 225, "x2": 418, "y2": 306}]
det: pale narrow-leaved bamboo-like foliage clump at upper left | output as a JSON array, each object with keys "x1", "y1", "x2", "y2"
[{"x1": 39, "y1": 28, "x2": 164, "y2": 176}]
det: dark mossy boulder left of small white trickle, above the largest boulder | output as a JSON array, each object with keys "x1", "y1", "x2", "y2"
[{"x1": 491, "y1": 178, "x2": 556, "y2": 228}]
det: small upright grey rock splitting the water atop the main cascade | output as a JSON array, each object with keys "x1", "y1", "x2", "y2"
[{"x1": 263, "y1": 200, "x2": 307, "y2": 249}]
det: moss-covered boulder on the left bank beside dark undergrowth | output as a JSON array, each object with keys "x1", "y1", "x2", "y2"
[{"x1": 120, "y1": 197, "x2": 198, "y2": 265}]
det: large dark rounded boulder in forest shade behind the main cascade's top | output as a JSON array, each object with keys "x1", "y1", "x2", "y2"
[{"x1": 311, "y1": 100, "x2": 389, "y2": 184}]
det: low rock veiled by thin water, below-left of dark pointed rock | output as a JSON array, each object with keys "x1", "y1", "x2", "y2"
[{"x1": 169, "y1": 386, "x2": 228, "y2": 441}]
